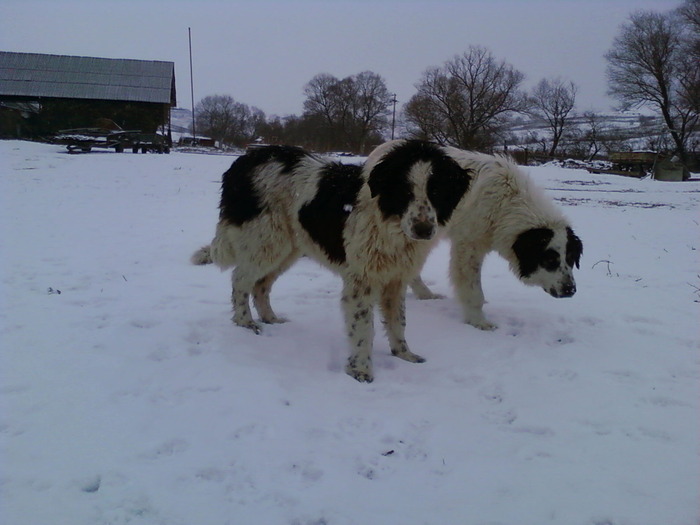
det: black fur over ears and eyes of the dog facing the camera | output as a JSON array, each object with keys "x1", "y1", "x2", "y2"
[{"x1": 369, "y1": 140, "x2": 471, "y2": 224}]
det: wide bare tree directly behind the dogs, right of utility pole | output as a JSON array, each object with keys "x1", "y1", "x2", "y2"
[{"x1": 404, "y1": 46, "x2": 526, "y2": 149}]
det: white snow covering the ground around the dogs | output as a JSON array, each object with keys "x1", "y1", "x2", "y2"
[{"x1": 0, "y1": 141, "x2": 700, "y2": 525}]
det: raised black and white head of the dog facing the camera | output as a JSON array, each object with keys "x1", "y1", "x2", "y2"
[{"x1": 368, "y1": 140, "x2": 471, "y2": 240}]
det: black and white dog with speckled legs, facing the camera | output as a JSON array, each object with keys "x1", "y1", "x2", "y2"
[{"x1": 192, "y1": 142, "x2": 471, "y2": 382}]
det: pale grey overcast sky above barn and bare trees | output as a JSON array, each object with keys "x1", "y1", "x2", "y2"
[{"x1": 0, "y1": 0, "x2": 681, "y2": 116}]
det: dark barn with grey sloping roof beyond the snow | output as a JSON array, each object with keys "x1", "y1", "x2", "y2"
[{"x1": 0, "y1": 51, "x2": 176, "y2": 138}]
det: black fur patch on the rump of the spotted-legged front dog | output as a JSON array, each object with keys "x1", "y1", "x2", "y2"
[{"x1": 219, "y1": 146, "x2": 308, "y2": 226}]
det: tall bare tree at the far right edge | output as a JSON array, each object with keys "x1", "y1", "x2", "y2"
[{"x1": 605, "y1": 11, "x2": 699, "y2": 162}]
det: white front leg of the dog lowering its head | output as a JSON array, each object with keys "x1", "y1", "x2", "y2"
[{"x1": 450, "y1": 242, "x2": 498, "y2": 330}]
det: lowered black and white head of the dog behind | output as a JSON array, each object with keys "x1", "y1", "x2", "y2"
[{"x1": 513, "y1": 226, "x2": 583, "y2": 297}]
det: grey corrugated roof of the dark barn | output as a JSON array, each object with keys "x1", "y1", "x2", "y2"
[{"x1": 0, "y1": 51, "x2": 175, "y2": 104}]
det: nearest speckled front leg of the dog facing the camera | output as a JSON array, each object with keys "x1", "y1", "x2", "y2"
[{"x1": 342, "y1": 277, "x2": 374, "y2": 383}]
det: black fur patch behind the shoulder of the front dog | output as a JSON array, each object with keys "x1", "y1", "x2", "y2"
[{"x1": 299, "y1": 163, "x2": 363, "y2": 264}]
